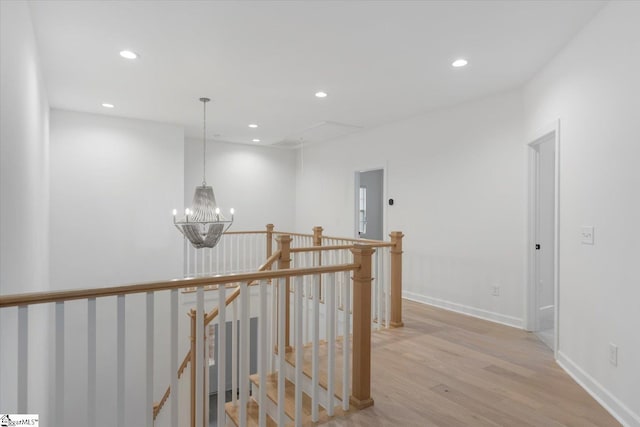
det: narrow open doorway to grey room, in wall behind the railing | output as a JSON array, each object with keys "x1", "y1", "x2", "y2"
[{"x1": 355, "y1": 169, "x2": 384, "y2": 240}]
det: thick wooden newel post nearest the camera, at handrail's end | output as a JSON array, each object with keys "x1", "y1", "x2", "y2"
[{"x1": 349, "y1": 243, "x2": 374, "y2": 409}]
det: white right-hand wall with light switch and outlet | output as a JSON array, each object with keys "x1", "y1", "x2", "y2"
[{"x1": 524, "y1": 2, "x2": 640, "y2": 425}]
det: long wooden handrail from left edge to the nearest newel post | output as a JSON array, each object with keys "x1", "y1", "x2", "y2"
[{"x1": 0, "y1": 264, "x2": 360, "y2": 308}]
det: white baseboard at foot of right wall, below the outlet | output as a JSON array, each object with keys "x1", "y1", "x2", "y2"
[{"x1": 557, "y1": 351, "x2": 640, "y2": 427}]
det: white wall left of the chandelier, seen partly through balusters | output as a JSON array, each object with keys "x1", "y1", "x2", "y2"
[{"x1": 51, "y1": 110, "x2": 186, "y2": 426}]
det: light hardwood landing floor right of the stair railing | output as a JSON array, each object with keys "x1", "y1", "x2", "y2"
[{"x1": 325, "y1": 300, "x2": 620, "y2": 427}]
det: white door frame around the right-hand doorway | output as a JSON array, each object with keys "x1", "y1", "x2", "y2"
[{"x1": 525, "y1": 119, "x2": 560, "y2": 359}]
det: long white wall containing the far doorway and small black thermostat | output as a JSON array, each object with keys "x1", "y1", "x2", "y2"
[{"x1": 296, "y1": 91, "x2": 526, "y2": 326}]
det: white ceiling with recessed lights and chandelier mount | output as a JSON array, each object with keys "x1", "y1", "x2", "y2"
[{"x1": 31, "y1": 0, "x2": 603, "y2": 144}]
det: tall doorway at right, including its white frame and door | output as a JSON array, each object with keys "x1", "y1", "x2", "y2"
[{"x1": 528, "y1": 126, "x2": 559, "y2": 353}]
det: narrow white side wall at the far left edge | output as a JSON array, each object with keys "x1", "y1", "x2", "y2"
[{"x1": 0, "y1": 1, "x2": 49, "y2": 425}]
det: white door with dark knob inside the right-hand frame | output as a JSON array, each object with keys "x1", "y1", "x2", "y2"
[{"x1": 532, "y1": 134, "x2": 556, "y2": 349}]
